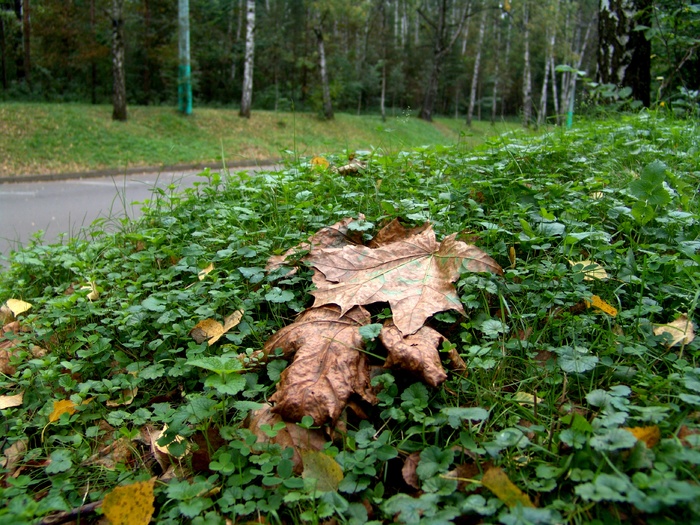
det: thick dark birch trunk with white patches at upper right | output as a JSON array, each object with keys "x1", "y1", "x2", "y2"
[{"x1": 597, "y1": 0, "x2": 652, "y2": 107}]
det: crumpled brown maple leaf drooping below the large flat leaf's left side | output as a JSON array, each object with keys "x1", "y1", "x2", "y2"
[{"x1": 264, "y1": 306, "x2": 375, "y2": 425}]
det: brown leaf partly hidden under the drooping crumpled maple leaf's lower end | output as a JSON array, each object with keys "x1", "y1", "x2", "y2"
[{"x1": 248, "y1": 405, "x2": 327, "y2": 474}]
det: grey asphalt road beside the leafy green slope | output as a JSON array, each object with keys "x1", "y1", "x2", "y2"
[{"x1": 0, "y1": 166, "x2": 274, "y2": 266}]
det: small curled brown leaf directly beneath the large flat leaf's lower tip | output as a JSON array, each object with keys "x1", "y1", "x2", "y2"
[{"x1": 379, "y1": 320, "x2": 447, "y2": 387}]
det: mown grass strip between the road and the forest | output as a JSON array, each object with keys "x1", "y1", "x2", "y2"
[{"x1": 0, "y1": 103, "x2": 517, "y2": 178}]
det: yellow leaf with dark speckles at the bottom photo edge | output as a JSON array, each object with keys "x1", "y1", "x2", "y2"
[{"x1": 102, "y1": 479, "x2": 155, "y2": 525}]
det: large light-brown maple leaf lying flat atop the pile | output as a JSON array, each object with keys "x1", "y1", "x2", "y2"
[{"x1": 308, "y1": 221, "x2": 503, "y2": 335}]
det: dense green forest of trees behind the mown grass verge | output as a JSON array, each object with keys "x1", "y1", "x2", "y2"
[{"x1": 0, "y1": 0, "x2": 700, "y2": 125}]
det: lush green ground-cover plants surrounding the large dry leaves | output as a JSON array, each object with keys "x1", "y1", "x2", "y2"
[{"x1": 0, "y1": 108, "x2": 700, "y2": 524}]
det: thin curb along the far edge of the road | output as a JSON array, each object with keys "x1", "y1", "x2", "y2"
[{"x1": 0, "y1": 159, "x2": 282, "y2": 184}]
